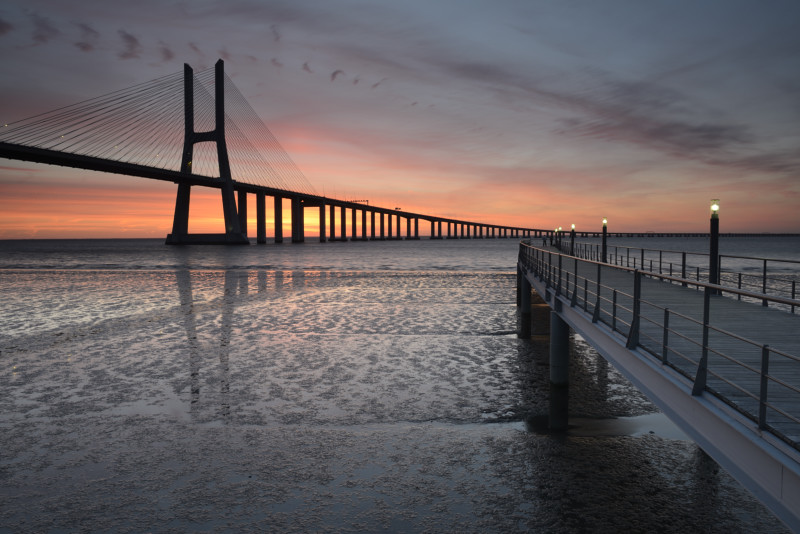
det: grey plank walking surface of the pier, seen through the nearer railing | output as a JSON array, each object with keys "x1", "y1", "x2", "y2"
[{"x1": 540, "y1": 249, "x2": 800, "y2": 445}]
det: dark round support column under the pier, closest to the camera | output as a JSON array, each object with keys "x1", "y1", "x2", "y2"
[{"x1": 549, "y1": 311, "x2": 569, "y2": 430}]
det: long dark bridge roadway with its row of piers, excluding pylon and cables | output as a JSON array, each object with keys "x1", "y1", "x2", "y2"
[{"x1": 0, "y1": 142, "x2": 536, "y2": 243}]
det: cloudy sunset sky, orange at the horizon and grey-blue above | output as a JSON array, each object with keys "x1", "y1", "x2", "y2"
[{"x1": 0, "y1": 0, "x2": 800, "y2": 239}]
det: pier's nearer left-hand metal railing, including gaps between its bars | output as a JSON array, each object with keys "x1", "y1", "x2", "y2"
[{"x1": 519, "y1": 242, "x2": 800, "y2": 449}]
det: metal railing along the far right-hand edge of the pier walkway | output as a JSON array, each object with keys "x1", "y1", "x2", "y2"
[{"x1": 562, "y1": 242, "x2": 800, "y2": 313}]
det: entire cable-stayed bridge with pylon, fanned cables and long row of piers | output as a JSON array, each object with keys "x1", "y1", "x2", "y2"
[{"x1": 0, "y1": 59, "x2": 548, "y2": 244}]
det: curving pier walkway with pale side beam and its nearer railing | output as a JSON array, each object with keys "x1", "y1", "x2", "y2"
[{"x1": 519, "y1": 244, "x2": 800, "y2": 532}]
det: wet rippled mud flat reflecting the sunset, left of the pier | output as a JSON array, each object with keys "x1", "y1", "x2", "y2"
[{"x1": 0, "y1": 270, "x2": 785, "y2": 533}]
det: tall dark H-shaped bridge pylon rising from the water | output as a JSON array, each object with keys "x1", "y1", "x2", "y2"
[{"x1": 166, "y1": 59, "x2": 250, "y2": 245}]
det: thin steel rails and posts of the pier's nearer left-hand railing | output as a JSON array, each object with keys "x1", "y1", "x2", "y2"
[{"x1": 519, "y1": 242, "x2": 800, "y2": 449}]
